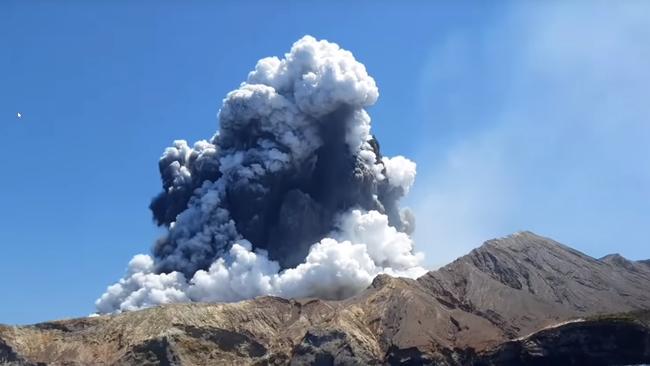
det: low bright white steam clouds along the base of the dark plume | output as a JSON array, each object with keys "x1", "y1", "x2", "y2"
[{"x1": 96, "y1": 210, "x2": 426, "y2": 313}]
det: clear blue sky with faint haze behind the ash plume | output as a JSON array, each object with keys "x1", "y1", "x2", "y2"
[{"x1": 0, "y1": 0, "x2": 650, "y2": 323}]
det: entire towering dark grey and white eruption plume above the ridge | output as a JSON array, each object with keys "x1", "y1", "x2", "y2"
[{"x1": 96, "y1": 36, "x2": 425, "y2": 313}]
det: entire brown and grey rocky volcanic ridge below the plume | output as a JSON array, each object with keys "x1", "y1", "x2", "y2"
[{"x1": 0, "y1": 232, "x2": 650, "y2": 365}]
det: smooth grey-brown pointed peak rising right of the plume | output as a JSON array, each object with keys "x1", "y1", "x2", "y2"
[{"x1": 418, "y1": 232, "x2": 650, "y2": 337}]
